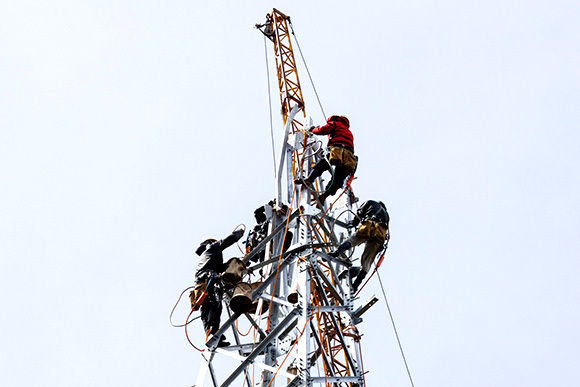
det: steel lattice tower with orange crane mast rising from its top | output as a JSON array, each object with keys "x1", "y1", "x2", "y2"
[{"x1": 190, "y1": 9, "x2": 376, "y2": 387}]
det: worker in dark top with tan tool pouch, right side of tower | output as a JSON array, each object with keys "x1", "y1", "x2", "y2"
[{"x1": 330, "y1": 200, "x2": 389, "y2": 292}]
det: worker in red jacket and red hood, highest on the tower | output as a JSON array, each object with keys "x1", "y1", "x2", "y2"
[{"x1": 295, "y1": 116, "x2": 358, "y2": 204}]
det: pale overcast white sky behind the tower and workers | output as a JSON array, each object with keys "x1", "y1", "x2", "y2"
[{"x1": 0, "y1": 0, "x2": 580, "y2": 387}]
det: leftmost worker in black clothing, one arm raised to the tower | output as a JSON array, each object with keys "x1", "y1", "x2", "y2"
[{"x1": 195, "y1": 229, "x2": 244, "y2": 347}]
